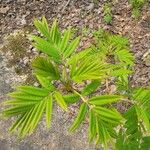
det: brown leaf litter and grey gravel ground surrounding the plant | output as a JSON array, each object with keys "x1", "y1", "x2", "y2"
[{"x1": 0, "y1": 0, "x2": 150, "y2": 150}]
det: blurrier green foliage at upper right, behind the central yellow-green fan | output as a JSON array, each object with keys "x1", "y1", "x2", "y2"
[{"x1": 93, "y1": 29, "x2": 134, "y2": 96}]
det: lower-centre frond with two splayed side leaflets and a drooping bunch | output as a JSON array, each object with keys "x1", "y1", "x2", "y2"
[{"x1": 70, "y1": 95, "x2": 124, "y2": 149}]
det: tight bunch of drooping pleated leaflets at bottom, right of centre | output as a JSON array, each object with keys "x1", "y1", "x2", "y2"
[{"x1": 89, "y1": 107, "x2": 123, "y2": 150}]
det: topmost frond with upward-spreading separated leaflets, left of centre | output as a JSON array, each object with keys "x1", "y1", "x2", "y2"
[{"x1": 31, "y1": 17, "x2": 80, "y2": 62}]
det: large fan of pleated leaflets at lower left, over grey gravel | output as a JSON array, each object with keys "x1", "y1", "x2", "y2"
[{"x1": 3, "y1": 86, "x2": 53, "y2": 137}]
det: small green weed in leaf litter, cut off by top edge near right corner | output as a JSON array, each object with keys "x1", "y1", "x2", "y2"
[{"x1": 129, "y1": 0, "x2": 147, "y2": 18}]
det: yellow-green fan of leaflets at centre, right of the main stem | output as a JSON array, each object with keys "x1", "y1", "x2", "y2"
[{"x1": 68, "y1": 48, "x2": 109, "y2": 82}]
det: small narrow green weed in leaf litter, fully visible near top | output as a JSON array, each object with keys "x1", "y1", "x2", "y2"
[{"x1": 103, "y1": 2, "x2": 113, "y2": 24}]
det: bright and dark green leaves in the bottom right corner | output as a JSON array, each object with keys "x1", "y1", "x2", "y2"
[{"x1": 116, "y1": 88, "x2": 150, "y2": 150}]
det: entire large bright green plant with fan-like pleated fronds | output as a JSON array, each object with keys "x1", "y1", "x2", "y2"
[{"x1": 2, "y1": 17, "x2": 150, "y2": 150}]
